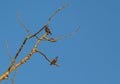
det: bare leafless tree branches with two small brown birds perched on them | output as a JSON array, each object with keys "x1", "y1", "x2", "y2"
[{"x1": 0, "y1": 4, "x2": 78, "y2": 84}]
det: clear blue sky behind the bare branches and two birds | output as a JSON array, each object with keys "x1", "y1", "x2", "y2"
[{"x1": 0, "y1": 0, "x2": 120, "y2": 84}]
